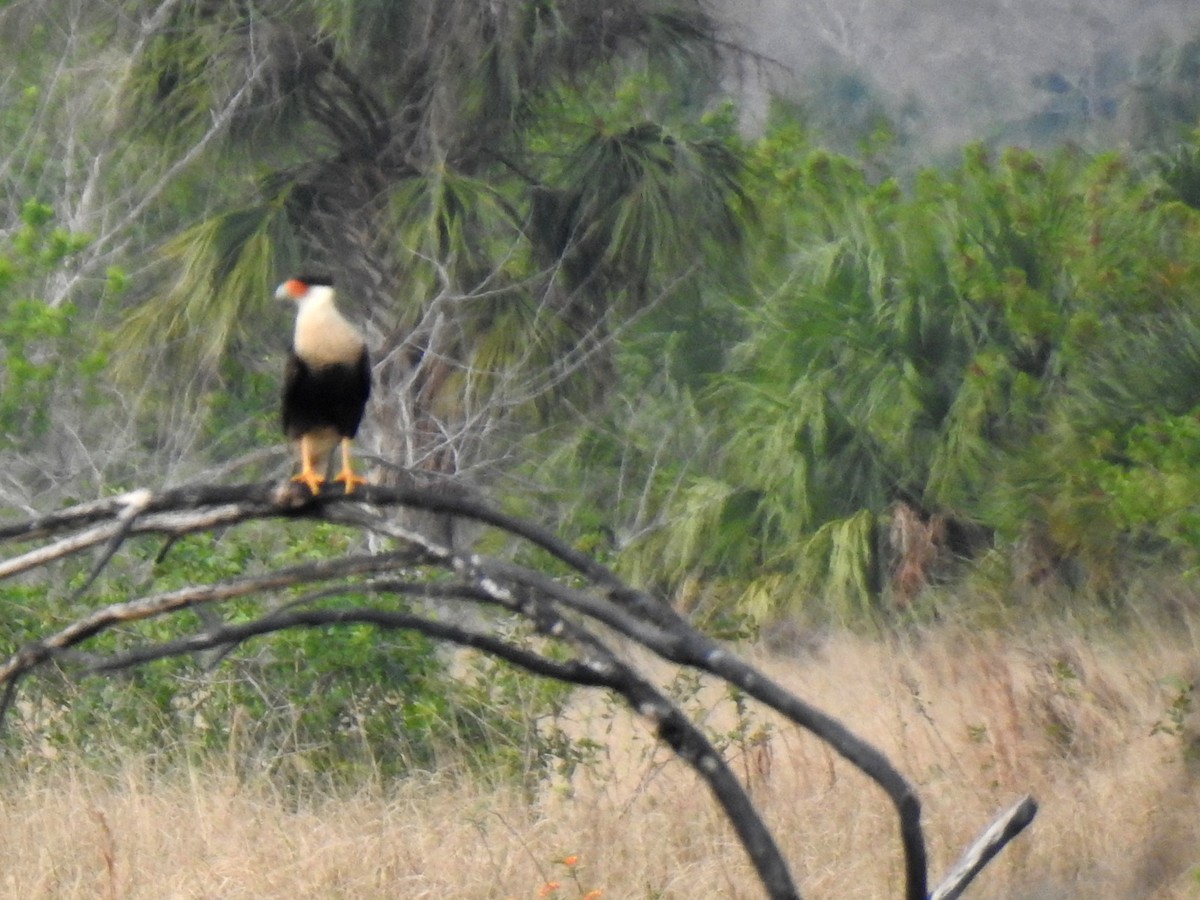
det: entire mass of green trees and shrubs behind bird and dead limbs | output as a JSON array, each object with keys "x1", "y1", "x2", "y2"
[{"x1": 7, "y1": 0, "x2": 1200, "y2": 897}]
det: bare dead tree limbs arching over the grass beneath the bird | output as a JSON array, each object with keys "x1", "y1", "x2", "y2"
[{"x1": 0, "y1": 484, "x2": 1036, "y2": 900}]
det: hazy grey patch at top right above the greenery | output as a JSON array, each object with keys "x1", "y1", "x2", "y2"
[{"x1": 726, "y1": 0, "x2": 1200, "y2": 152}]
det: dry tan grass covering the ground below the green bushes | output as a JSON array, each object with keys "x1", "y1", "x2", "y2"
[{"x1": 0, "y1": 628, "x2": 1200, "y2": 900}]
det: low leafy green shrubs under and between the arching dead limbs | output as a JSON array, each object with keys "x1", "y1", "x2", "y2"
[{"x1": 0, "y1": 524, "x2": 570, "y2": 782}]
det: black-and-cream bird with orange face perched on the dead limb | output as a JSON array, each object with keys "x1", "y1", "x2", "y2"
[{"x1": 275, "y1": 275, "x2": 371, "y2": 496}]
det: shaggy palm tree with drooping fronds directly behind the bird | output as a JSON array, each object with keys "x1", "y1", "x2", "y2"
[{"x1": 114, "y1": 0, "x2": 748, "y2": 463}]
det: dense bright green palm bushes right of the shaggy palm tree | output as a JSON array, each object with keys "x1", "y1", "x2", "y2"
[{"x1": 631, "y1": 124, "x2": 1200, "y2": 620}]
